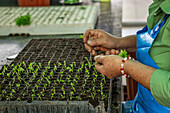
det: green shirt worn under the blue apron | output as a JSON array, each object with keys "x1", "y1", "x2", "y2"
[{"x1": 147, "y1": 0, "x2": 170, "y2": 107}]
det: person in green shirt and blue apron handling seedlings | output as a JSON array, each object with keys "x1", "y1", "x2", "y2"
[{"x1": 83, "y1": 0, "x2": 170, "y2": 113}]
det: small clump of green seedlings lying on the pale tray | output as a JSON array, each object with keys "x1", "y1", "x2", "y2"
[{"x1": 16, "y1": 13, "x2": 31, "y2": 26}]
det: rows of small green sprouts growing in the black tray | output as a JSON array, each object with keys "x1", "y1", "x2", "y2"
[{"x1": 0, "y1": 57, "x2": 108, "y2": 101}]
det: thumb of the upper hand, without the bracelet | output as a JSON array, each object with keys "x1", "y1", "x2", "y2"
[{"x1": 87, "y1": 38, "x2": 104, "y2": 46}]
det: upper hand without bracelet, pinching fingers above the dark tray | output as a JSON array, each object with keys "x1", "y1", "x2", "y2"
[{"x1": 83, "y1": 29, "x2": 118, "y2": 55}]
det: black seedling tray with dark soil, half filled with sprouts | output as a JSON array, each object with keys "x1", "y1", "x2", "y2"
[{"x1": 0, "y1": 39, "x2": 121, "y2": 113}]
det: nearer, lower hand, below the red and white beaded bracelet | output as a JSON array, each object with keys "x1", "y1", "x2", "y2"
[{"x1": 94, "y1": 55, "x2": 123, "y2": 79}]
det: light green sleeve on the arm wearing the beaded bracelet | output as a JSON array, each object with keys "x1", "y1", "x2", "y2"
[{"x1": 150, "y1": 69, "x2": 170, "y2": 107}]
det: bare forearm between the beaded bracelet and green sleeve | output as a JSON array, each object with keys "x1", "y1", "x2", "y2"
[{"x1": 124, "y1": 60, "x2": 156, "y2": 90}]
